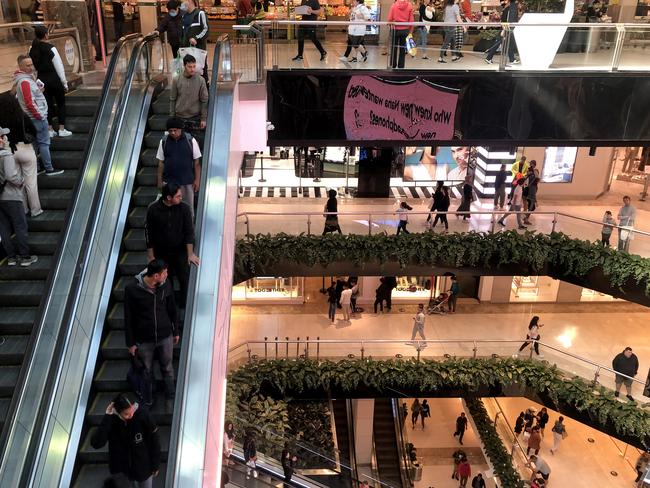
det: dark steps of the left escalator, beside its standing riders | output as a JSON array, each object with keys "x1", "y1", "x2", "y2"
[{"x1": 0, "y1": 88, "x2": 101, "y2": 426}]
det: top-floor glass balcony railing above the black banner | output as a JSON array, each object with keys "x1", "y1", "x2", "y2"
[{"x1": 232, "y1": 18, "x2": 650, "y2": 82}]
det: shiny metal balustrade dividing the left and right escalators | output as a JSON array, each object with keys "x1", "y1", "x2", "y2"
[{"x1": 0, "y1": 34, "x2": 170, "y2": 487}]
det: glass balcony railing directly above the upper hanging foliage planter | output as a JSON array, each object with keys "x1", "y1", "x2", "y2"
[{"x1": 237, "y1": 208, "x2": 650, "y2": 257}]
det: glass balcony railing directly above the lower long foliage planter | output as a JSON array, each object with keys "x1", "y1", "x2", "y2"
[{"x1": 228, "y1": 337, "x2": 646, "y2": 395}]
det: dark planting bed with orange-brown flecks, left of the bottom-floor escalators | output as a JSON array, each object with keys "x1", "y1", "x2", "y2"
[{"x1": 287, "y1": 400, "x2": 336, "y2": 469}]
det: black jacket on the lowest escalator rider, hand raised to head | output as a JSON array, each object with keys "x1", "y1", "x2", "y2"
[{"x1": 90, "y1": 409, "x2": 160, "y2": 481}]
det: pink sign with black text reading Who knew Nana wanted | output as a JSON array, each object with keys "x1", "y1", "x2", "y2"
[{"x1": 344, "y1": 76, "x2": 458, "y2": 141}]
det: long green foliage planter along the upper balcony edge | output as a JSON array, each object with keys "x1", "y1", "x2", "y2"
[{"x1": 235, "y1": 231, "x2": 650, "y2": 296}]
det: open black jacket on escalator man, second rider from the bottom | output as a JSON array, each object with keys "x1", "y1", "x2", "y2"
[{"x1": 124, "y1": 271, "x2": 178, "y2": 347}]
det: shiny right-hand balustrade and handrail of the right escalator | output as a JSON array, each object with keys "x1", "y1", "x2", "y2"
[{"x1": 165, "y1": 35, "x2": 231, "y2": 487}]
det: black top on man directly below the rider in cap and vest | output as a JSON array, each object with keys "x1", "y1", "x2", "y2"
[{"x1": 144, "y1": 197, "x2": 194, "y2": 252}]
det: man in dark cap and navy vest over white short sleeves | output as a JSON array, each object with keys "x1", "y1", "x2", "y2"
[{"x1": 156, "y1": 117, "x2": 201, "y2": 217}]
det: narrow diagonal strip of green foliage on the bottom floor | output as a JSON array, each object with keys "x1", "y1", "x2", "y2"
[{"x1": 465, "y1": 398, "x2": 525, "y2": 488}]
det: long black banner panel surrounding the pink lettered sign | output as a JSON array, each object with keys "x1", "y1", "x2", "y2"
[{"x1": 267, "y1": 70, "x2": 650, "y2": 146}]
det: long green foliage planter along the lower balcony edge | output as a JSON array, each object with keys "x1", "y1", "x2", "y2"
[{"x1": 228, "y1": 358, "x2": 650, "y2": 442}]
